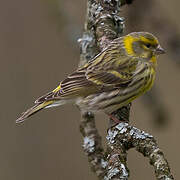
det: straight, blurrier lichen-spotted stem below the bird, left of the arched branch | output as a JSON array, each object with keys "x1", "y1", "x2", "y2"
[{"x1": 80, "y1": 112, "x2": 107, "y2": 179}]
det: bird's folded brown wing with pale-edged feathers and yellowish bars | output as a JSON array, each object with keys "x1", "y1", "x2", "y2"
[{"x1": 35, "y1": 67, "x2": 132, "y2": 103}]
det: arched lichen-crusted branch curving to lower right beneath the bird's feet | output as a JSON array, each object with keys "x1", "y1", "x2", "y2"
[{"x1": 107, "y1": 122, "x2": 173, "y2": 180}]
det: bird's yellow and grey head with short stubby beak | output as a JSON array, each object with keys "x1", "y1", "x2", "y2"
[{"x1": 124, "y1": 32, "x2": 165, "y2": 61}]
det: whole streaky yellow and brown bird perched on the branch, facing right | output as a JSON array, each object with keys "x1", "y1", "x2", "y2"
[{"x1": 16, "y1": 32, "x2": 165, "y2": 123}]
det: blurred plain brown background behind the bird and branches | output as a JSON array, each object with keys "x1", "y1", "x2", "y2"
[{"x1": 0, "y1": 0, "x2": 180, "y2": 180}]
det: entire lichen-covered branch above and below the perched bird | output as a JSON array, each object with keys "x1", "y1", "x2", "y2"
[{"x1": 79, "y1": 0, "x2": 173, "y2": 180}]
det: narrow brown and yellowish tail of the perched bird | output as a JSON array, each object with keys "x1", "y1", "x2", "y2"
[{"x1": 16, "y1": 101, "x2": 53, "y2": 123}]
